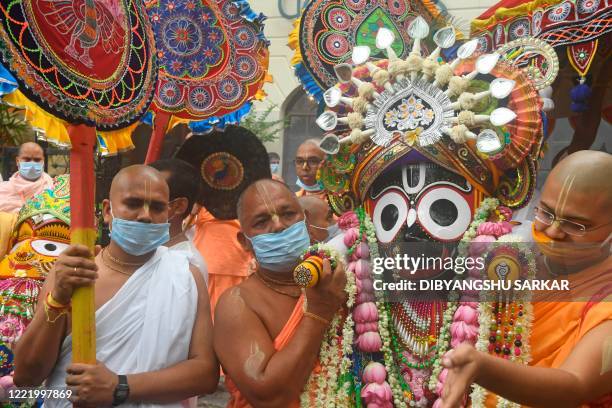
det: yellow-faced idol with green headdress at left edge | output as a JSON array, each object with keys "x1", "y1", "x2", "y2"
[{"x1": 0, "y1": 175, "x2": 70, "y2": 391}]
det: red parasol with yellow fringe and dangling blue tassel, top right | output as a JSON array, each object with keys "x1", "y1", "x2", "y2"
[{"x1": 472, "y1": 0, "x2": 612, "y2": 161}]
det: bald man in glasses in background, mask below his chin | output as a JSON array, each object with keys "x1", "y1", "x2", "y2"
[{"x1": 294, "y1": 139, "x2": 325, "y2": 199}]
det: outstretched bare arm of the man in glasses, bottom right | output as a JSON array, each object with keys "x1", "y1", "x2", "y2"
[{"x1": 444, "y1": 321, "x2": 612, "y2": 408}]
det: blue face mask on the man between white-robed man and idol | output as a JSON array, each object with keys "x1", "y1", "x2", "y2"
[{"x1": 245, "y1": 220, "x2": 310, "y2": 272}]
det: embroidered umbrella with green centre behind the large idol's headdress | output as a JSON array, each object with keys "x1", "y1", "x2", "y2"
[{"x1": 289, "y1": 0, "x2": 446, "y2": 102}]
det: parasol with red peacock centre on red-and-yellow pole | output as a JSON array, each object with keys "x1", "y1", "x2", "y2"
[{"x1": 0, "y1": 0, "x2": 157, "y2": 363}]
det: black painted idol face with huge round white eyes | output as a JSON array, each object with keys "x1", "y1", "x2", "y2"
[{"x1": 368, "y1": 162, "x2": 478, "y2": 275}]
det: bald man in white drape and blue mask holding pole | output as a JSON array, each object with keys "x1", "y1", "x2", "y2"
[{"x1": 14, "y1": 166, "x2": 219, "y2": 408}]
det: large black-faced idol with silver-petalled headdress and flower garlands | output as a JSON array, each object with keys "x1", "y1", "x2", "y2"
[{"x1": 290, "y1": 2, "x2": 558, "y2": 407}]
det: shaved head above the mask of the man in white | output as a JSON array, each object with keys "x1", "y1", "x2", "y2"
[{"x1": 104, "y1": 165, "x2": 170, "y2": 224}]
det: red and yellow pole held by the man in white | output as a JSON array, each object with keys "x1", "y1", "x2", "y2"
[{"x1": 68, "y1": 125, "x2": 97, "y2": 364}]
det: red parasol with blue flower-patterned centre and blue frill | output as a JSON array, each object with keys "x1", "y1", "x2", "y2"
[{"x1": 145, "y1": 0, "x2": 268, "y2": 163}]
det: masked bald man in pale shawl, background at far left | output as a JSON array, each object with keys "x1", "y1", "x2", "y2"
[{"x1": 0, "y1": 142, "x2": 53, "y2": 213}]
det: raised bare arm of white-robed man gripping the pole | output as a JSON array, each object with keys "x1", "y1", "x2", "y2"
[{"x1": 14, "y1": 245, "x2": 97, "y2": 387}]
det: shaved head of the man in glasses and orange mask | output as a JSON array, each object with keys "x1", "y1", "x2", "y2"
[{"x1": 535, "y1": 150, "x2": 612, "y2": 242}]
